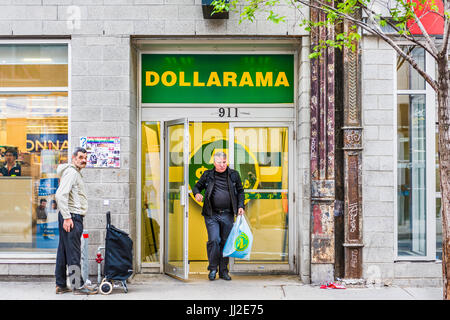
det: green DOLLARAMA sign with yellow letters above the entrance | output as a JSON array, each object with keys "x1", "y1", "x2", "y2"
[{"x1": 141, "y1": 54, "x2": 295, "y2": 103}]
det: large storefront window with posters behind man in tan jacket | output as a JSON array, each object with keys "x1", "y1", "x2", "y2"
[{"x1": 0, "y1": 44, "x2": 68, "y2": 252}]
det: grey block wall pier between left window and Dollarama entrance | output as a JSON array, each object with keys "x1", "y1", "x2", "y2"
[{"x1": 70, "y1": 35, "x2": 136, "y2": 272}]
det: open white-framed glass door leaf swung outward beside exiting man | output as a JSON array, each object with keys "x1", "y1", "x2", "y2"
[{"x1": 164, "y1": 119, "x2": 189, "y2": 279}]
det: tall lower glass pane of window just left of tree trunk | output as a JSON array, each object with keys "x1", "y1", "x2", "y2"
[{"x1": 397, "y1": 95, "x2": 426, "y2": 256}]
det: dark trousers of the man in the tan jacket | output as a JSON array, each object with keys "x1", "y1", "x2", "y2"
[{"x1": 55, "y1": 213, "x2": 84, "y2": 288}]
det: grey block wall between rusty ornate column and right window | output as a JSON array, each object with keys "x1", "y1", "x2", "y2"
[{"x1": 362, "y1": 36, "x2": 442, "y2": 286}]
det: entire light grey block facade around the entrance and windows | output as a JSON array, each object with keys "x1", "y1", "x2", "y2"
[{"x1": 0, "y1": 0, "x2": 441, "y2": 285}]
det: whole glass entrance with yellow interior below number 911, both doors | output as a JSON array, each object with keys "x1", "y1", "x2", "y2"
[{"x1": 140, "y1": 119, "x2": 296, "y2": 279}]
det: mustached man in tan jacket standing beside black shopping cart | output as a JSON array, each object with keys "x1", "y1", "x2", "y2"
[{"x1": 55, "y1": 148, "x2": 96, "y2": 294}]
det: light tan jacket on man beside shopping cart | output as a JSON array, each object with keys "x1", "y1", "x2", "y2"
[{"x1": 55, "y1": 164, "x2": 88, "y2": 219}]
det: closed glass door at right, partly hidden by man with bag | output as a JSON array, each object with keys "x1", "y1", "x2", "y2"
[{"x1": 229, "y1": 123, "x2": 293, "y2": 272}]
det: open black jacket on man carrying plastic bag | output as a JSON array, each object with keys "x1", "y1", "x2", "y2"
[{"x1": 192, "y1": 168, "x2": 245, "y2": 216}]
